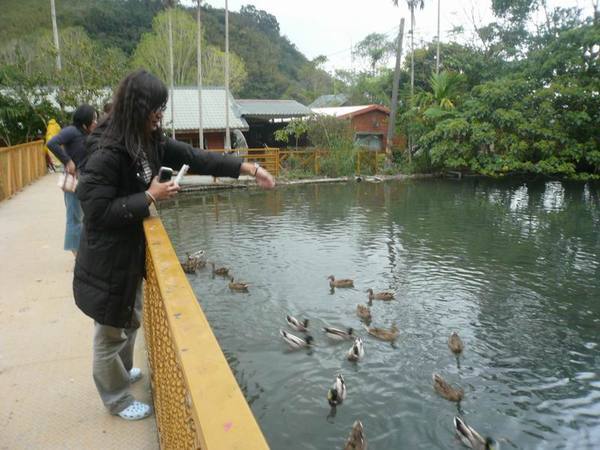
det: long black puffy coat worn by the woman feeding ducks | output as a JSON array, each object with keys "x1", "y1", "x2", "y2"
[{"x1": 73, "y1": 124, "x2": 242, "y2": 328}]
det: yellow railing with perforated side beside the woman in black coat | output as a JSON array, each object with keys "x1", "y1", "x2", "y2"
[{"x1": 144, "y1": 217, "x2": 268, "y2": 450}]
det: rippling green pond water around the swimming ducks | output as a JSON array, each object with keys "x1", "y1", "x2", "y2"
[{"x1": 161, "y1": 179, "x2": 600, "y2": 450}]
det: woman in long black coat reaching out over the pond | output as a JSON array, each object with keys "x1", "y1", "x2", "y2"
[{"x1": 73, "y1": 70, "x2": 275, "y2": 420}]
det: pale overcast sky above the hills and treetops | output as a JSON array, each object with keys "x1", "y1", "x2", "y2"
[{"x1": 182, "y1": 0, "x2": 592, "y2": 71}]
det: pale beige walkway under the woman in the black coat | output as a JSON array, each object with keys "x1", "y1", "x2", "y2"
[{"x1": 0, "y1": 175, "x2": 159, "y2": 450}]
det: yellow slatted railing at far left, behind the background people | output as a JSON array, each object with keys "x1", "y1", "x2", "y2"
[{"x1": 0, "y1": 141, "x2": 46, "y2": 200}]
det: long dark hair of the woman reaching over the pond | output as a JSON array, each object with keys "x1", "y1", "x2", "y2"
[{"x1": 102, "y1": 69, "x2": 169, "y2": 166}]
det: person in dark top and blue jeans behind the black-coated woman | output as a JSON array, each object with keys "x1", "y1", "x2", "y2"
[{"x1": 46, "y1": 104, "x2": 98, "y2": 256}]
